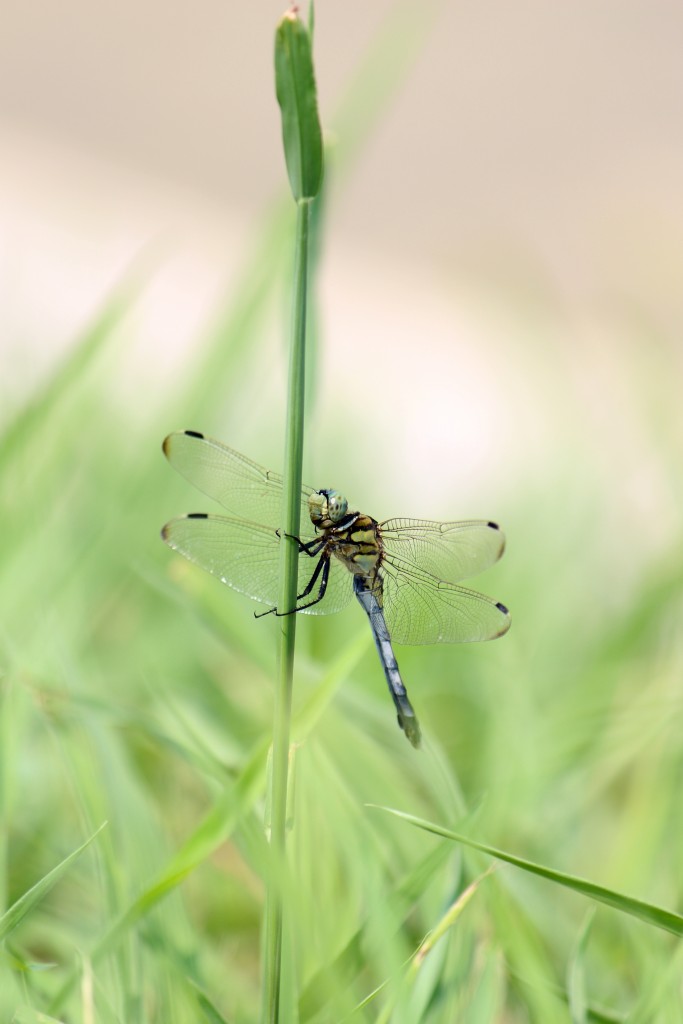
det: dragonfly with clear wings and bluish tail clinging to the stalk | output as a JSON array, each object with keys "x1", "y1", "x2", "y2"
[{"x1": 162, "y1": 430, "x2": 510, "y2": 748}]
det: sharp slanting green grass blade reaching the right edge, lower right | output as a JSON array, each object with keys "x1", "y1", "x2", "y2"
[{"x1": 370, "y1": 805, "x2": 683, "y2": 938}]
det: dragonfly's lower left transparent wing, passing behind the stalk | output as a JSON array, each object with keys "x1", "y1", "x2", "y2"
[{"x1": 162, "y1": 514, "x2": 352, "y2": 615}]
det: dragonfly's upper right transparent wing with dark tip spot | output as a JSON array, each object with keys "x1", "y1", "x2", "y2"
[{"x1": 380, "y1": 519, "x2": 505, "y2": 583}]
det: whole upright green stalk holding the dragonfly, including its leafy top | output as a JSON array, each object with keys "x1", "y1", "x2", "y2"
[{"x1": 261, "y1": 11, "x2": 323, "y2": 1024}]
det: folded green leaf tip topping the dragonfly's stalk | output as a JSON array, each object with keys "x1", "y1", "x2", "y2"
[{"x1": 275, "y1": 8, "x2": 323, "y2": 202}]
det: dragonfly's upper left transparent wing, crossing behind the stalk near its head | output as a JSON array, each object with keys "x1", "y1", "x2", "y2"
[{"x1": 163, "y1": 430, "x2": 315, "y2": 541}]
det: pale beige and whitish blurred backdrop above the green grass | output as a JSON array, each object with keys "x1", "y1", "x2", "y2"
[{"x1": 0, "y1": 0, "x2": 683, "y2": 521}]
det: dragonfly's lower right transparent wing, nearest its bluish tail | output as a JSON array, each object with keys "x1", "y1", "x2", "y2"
[{"x1": 380, "y1": 555, "x2": 510, "y2": 644}]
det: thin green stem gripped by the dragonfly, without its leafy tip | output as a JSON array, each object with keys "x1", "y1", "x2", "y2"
[{"x1": 261, "y1": 200, "x2": 310, "y2": 1024}]
